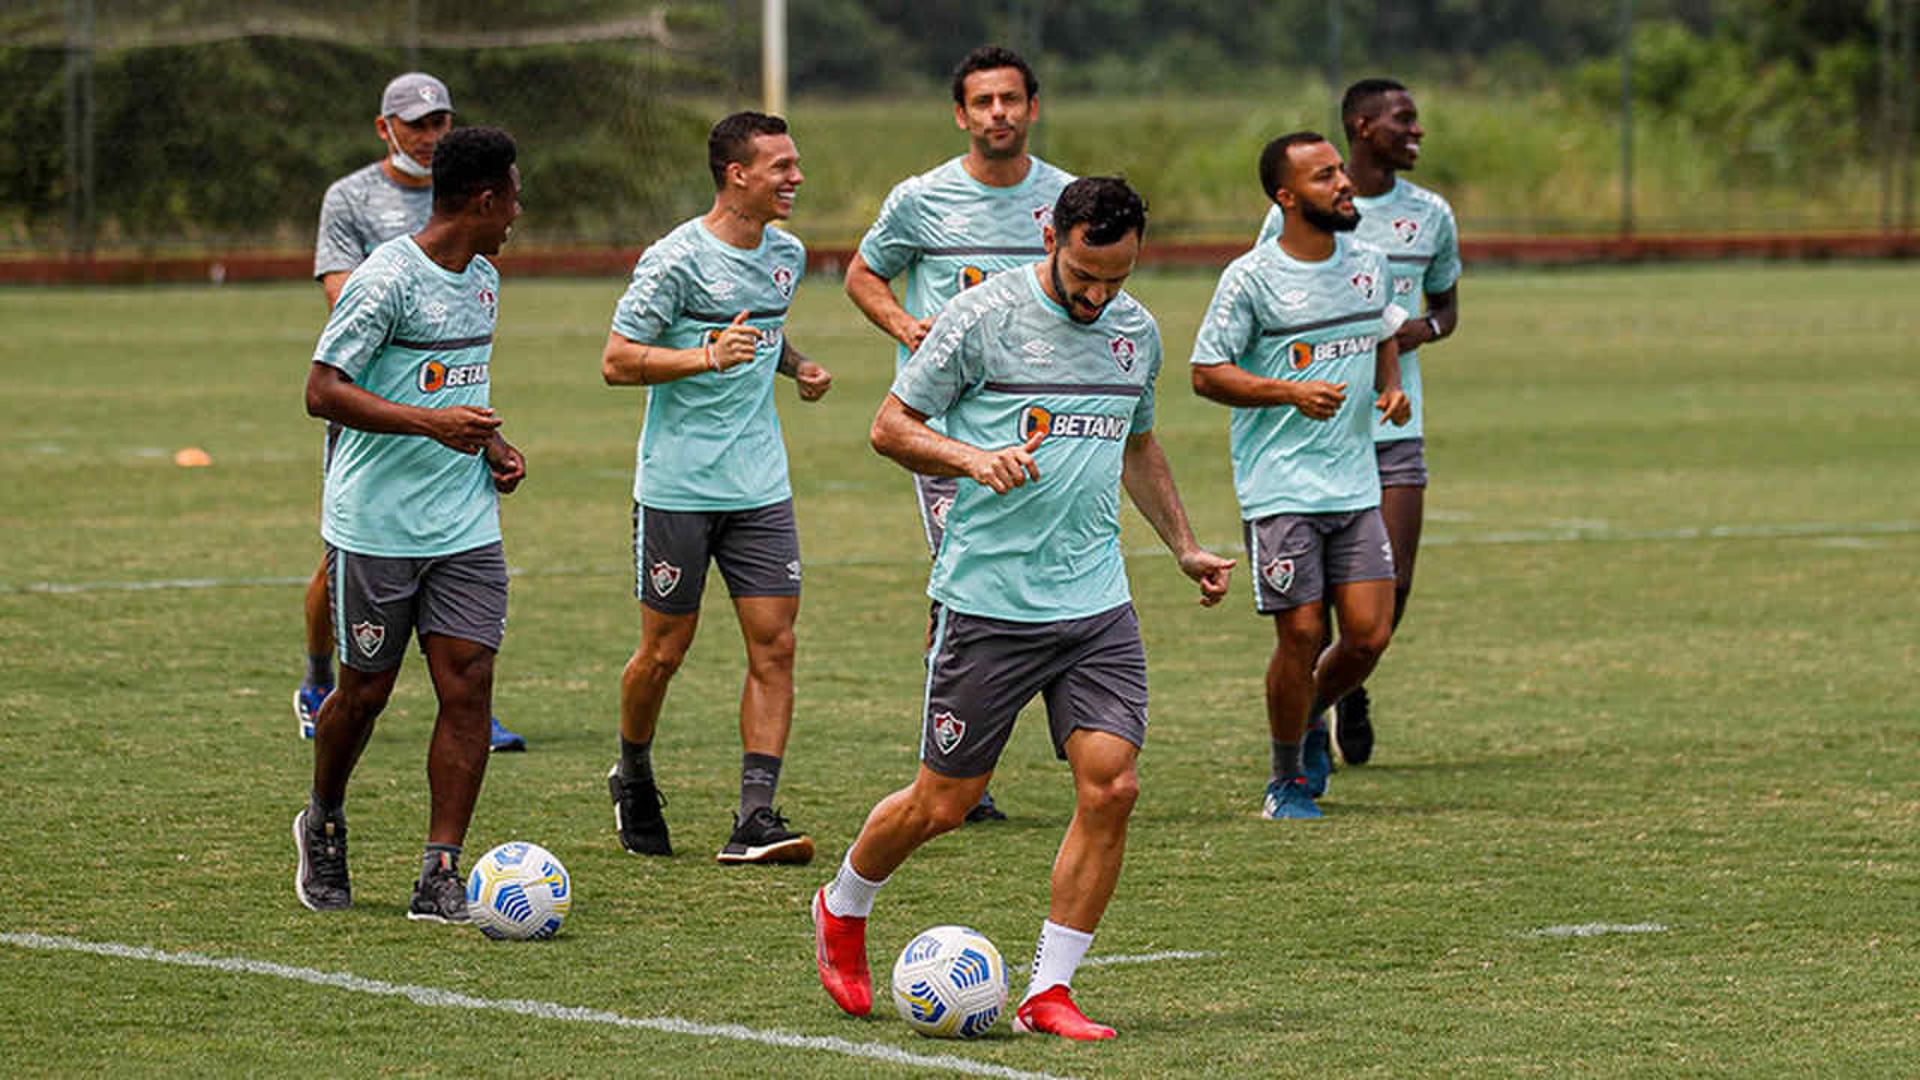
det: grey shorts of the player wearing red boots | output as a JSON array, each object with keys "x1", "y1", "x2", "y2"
[{"x1": 920, "y1": 603, "x2": 1146, "y2": 776}]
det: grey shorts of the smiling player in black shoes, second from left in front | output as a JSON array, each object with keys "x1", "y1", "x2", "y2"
[{"x1": 634, "y1": 500, "x2": 801, "y2": 615}]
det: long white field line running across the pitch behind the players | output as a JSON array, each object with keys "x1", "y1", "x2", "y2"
[{"x1": 0, "y1": 521, "x2": 1920, "y2": 596}]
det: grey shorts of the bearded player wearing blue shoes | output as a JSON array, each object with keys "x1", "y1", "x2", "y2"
[{"x1": 1240, "y1": 507, "x2": 1394, "y2": 615}]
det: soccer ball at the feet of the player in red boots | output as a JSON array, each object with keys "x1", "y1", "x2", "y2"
[{"x1": 893, "y1": 914, "x2": 1006, "y2": 1040}]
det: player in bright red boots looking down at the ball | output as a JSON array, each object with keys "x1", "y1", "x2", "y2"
[{"x1": 812, "y1": 177, "x2": 1233, "y2": 1040}]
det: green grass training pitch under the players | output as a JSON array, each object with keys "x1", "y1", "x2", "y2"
[{"x1": 0, "y1": 265, "x2": 1920, "y2": 1076}]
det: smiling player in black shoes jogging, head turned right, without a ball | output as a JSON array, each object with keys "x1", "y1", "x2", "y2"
[{"x1": 601, "y1": 111, "x2": 833, "y2": 863}]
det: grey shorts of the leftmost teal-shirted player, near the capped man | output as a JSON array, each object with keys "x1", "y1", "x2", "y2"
[{"x1": 326, "y1": 540, "x2": 507, "y2": 671}]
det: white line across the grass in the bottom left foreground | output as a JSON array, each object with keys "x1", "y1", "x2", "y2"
[{"x1": 0, "y1": 934, "x2": 1064, "y2": 1080}]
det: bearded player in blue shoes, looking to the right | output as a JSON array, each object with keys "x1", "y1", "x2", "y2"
[{"x1": 1192, "y1": 131, "x2": 1407, "y2": 819}]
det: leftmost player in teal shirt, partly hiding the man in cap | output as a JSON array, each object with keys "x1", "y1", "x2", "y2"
[{"x1": 294, "y1": 127, "x2": 526, "y2": 922}]
